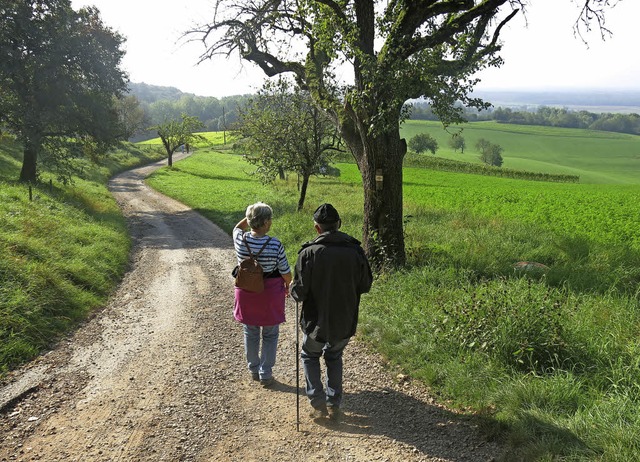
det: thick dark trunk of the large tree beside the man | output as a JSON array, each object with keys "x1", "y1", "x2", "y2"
[{"x1": 351, "y1": 127, "x2": 407, "y2": 267}]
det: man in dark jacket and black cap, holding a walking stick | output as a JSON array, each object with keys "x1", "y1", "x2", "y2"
[{"x1": 291, "y1": 204, "x2": 373, "y2": 420}]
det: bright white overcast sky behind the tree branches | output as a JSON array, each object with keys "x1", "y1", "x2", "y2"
[{"x1": 72, "y1": 0, "x2": 640, "y2": 98}]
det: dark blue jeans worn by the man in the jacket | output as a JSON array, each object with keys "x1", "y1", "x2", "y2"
[{"x1": 300, "y1": 334, "x2": 349, "y2": 408}]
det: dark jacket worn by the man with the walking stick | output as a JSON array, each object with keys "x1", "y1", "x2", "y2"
[{"x1": 291, "y1": 231, "x2": 373, "y2": 343}]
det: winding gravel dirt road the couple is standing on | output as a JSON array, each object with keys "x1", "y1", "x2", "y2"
[{"x1": 0, "y1": 157, "x2": 500, "y2": 462}]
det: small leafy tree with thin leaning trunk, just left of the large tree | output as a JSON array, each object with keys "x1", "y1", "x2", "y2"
[{"x1": 238, "y1": 79, "x2": 339, "y2": 210}]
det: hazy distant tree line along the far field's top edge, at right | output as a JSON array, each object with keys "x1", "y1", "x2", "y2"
[{"x1": 411, "y1": 102, "x2": 640, "y2": 135}]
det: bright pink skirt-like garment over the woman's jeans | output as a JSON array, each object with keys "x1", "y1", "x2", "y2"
[{"x1": 233, "y1": 278, "x2": 285, "y2": 326}]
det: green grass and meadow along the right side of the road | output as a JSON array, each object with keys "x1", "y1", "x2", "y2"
[{"x1": 149, "y1": 143, "x2": 640, "y2": 461}]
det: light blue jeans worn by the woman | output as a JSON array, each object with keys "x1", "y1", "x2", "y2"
[{"x1": 244, "y1": 324, "x2": 280, "y2": 380}]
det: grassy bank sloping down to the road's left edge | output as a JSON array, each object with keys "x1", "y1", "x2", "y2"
[{"x1": 0, "y1": 140, "x2": 161, "y2": 376}]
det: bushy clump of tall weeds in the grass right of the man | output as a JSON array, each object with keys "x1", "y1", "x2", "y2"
[{"x1": 439, "y1": 278, "x2": 572, "y2": 374}]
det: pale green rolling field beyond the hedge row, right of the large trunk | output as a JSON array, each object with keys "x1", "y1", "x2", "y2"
[{"x1": 402, "y1": 120, "x2": 640, "y2": 184}]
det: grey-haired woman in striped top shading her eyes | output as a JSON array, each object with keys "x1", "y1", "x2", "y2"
[{"x1": 233, "y1": 202, "x2": 291, "y2": 387}]
